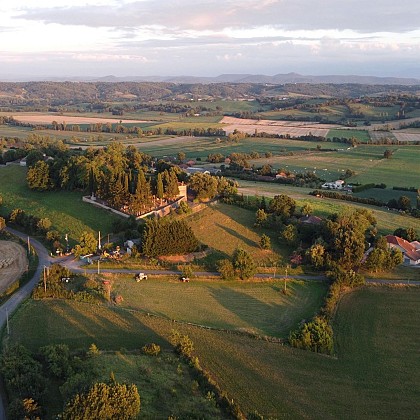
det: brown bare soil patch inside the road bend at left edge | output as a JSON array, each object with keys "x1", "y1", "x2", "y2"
[{"x1": 0, "y1": 241, "x2": 28, "y2": 293}]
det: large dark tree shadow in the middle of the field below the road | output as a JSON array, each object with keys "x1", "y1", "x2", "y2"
[{"x1": 210, "y1": 288, "x2": 288, "y2": 337}]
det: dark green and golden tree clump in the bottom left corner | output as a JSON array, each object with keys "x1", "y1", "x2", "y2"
[{"x1": 0, "y1": 344, "x2": 140, "y2": 420}]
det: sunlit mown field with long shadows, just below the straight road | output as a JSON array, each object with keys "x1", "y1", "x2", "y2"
[{"x1": 113, "y1": 276, "x2": 327, "y2": 338}]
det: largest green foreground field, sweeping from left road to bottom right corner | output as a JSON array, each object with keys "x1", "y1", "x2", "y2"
[{"x1": 9, "y1": 287, "x2": 420, "y2": 419}]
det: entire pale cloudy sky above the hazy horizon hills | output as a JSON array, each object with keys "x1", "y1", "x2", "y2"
[{"x1": 0, "y1": 0, "x2": 420, "y2": 80}]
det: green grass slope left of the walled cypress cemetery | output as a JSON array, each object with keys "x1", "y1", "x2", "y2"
[{"x1": 0, "y1": 165, "x2": 117, "y2": 242}]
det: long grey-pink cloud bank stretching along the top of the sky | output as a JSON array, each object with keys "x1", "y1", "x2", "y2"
[{"x1": 15, "y1": 0, "x2": 420, "y2": 32}]
